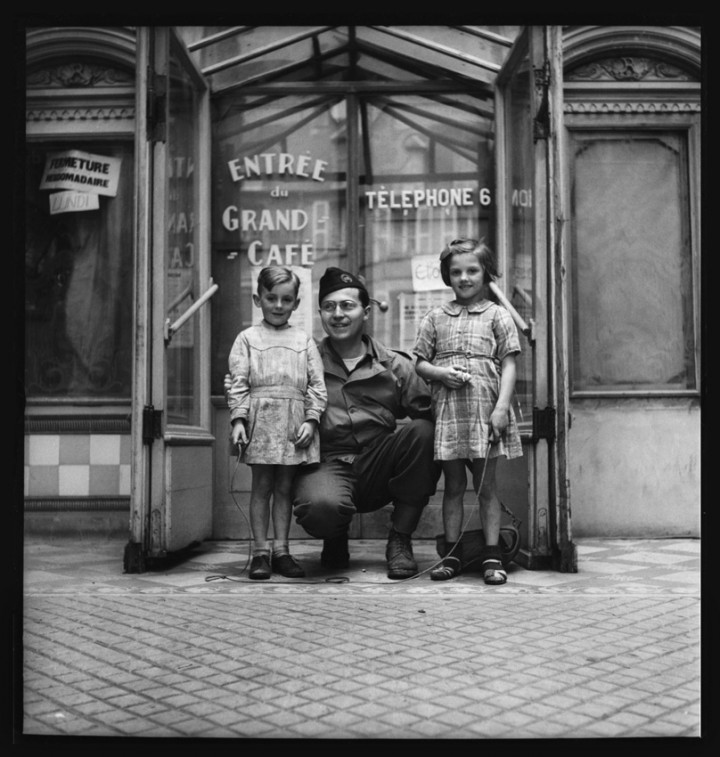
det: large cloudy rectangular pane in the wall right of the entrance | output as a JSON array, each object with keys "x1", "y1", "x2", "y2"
[{"x1": 572, "y1": 132, "x2": 695, "y2": 390}]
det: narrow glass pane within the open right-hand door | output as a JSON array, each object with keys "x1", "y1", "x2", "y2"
[{"x1": 499, "y1": 53, "x2": 535, "y2": 423}]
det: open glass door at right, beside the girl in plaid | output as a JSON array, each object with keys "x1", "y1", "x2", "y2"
[{"x1": 496, "y1": 26, "x2": 574, "y2": 570}]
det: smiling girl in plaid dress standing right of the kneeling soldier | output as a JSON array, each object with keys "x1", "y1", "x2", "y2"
[{"x1": 414, "y1": 239, "x2": 522, "y2": 584}]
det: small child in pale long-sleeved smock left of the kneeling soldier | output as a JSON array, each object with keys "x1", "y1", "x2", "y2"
[{"x1": 228, "y1": 266, "x2": 327, "y2": 580}]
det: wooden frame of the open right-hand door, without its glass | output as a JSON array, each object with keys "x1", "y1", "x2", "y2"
[{"x1": 496, "y1": 26, "x2": 577, "y2": 572}]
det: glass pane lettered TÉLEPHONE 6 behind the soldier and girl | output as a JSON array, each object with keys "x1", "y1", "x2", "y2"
[{"x1": 360, "y1": 95, "x2": 494, "y2": 352}]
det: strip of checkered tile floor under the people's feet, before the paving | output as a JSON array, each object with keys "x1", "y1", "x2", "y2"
[{"x1": 25, "y1": 539, "x2": 700, "y2": 596}]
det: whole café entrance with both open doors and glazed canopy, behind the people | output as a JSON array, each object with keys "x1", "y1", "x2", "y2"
[{"x1": 125, "y1": 26, "x2": 575, "y2": 572}]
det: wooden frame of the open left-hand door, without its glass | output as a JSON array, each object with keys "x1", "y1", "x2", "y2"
[{"x1": 124, "y1": 27, "x2": 217, "y2": 573}]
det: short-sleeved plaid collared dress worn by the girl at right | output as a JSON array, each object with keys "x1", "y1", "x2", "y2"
[{"x1": 413, "y1": 300, "x2": 522, "y2": 460}]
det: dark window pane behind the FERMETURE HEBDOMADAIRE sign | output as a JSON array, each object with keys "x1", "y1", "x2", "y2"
[{"x1": 25, "y1": 142, "x2": 133, "y2": 399}]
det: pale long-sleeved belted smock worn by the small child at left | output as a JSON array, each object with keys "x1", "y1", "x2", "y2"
[{"x1": 228, "y1": 321, "x2": 327, "y2": 465}]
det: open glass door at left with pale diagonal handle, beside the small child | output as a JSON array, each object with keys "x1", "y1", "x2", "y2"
[{"x1": 125, "y1": 27, "x2": 217, "y2": 572}]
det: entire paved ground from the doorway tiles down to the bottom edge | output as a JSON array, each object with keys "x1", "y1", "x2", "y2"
[{"x1": 20, "y1": 538, "x2": 701, "y2": 740}]
